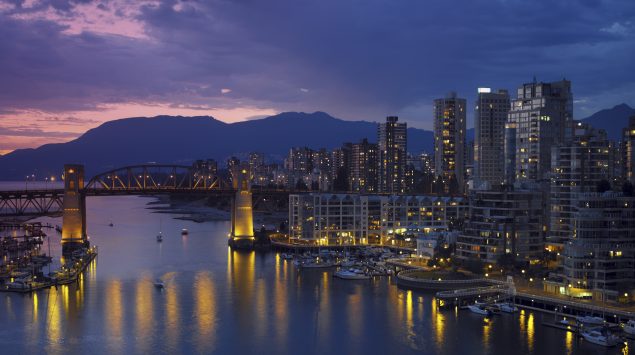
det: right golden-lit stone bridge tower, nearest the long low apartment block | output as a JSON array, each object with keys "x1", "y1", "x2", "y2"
[{"x1": 229, "y1": 163, "x2": 255, "y2": 249}]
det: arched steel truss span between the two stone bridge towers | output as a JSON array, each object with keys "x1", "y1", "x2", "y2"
[{"x1": 84, "y1": 164, "x2": 230, "y2": 194}]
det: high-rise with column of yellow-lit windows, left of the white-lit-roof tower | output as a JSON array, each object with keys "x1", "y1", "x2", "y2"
[{"x1": 434, "y1": 92, "x2": 466, "y2": 192}]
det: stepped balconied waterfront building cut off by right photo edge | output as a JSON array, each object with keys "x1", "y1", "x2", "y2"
[{"x1": 546, "y1": 192, "x2": 635, "y2": 301}]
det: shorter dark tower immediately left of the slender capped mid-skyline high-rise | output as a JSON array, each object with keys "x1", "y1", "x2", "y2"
[{"x1": 349, "y1": 138, "x2": 379, "y2": 192}]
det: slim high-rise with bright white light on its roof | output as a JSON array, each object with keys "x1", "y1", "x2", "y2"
[{"x1": 474, "y1": 88, "x2": 509, "y2": 187}]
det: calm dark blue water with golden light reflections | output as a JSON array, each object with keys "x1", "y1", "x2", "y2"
[{"x1": 0, "y1": 196, "x2": 620, "y2": 354}]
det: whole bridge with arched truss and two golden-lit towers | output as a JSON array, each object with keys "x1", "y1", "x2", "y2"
[{"x1": 0, "y1": 164, "x2": 288, "y2": 252}]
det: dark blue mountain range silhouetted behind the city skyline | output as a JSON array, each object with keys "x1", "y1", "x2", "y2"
[{"x1": 0, "y1": 104, "x2": 635, "y2": 180}]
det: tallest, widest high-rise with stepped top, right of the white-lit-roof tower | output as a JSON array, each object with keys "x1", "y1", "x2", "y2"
[{"x1": 507, "y1": 80, "x2": 573, "y2": 181}]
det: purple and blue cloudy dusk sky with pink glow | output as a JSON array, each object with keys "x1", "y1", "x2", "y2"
[{"x1": 0, "y1": 0, "x2": 635, "y2": 154}]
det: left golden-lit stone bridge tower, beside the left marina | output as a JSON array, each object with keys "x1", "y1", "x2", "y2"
[{"x1": 62, "y1": 164, "x2": 87, "y2": 254}]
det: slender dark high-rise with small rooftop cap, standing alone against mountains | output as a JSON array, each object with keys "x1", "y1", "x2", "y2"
[{"x1": 377, "y1": 116, "x2": 408, "y2": 193}]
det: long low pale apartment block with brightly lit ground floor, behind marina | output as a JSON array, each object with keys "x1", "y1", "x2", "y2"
[{"x1": 289, "y1": 194, "x2": 467, "y2": 244}]
